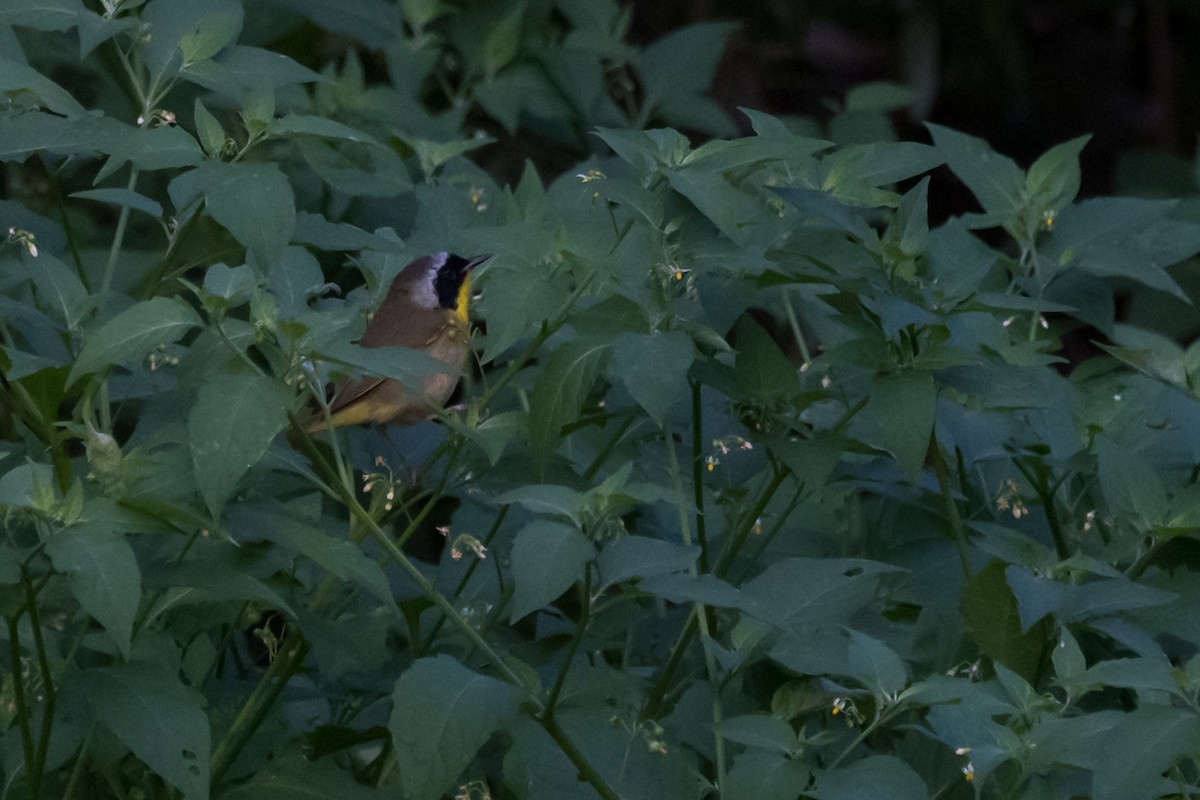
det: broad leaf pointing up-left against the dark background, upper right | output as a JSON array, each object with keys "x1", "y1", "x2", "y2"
[{"x1": 925, "y1": 122, "x2": 1025, "y2": 227}]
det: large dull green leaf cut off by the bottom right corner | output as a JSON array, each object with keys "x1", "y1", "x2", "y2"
[{"x1": 1092, "y1": 705, "x2": 1200, "y2": 800}]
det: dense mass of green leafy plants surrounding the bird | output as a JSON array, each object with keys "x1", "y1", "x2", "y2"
[{"x1": 7, "y1": 0, "x2": 1200, "y2": 800}]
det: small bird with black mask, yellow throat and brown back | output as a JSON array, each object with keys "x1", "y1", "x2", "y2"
[{"x1": 305, "y1": 253, "x2": 491, "y2": 433}]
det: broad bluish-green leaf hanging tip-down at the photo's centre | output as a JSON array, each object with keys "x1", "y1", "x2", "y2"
[{"x1": 610, "y1": 331, "x2": 696, "y2": 425}]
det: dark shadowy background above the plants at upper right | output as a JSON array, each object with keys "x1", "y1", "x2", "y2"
[{"x1": 631, "y1": 0, "x2": 1200, "y2": 196}]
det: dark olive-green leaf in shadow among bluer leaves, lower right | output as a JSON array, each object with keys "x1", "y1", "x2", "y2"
[{"x1": 960, "y1": 559, "x2": 1054, "y2": 680}]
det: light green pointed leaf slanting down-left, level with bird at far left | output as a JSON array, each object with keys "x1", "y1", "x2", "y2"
[{"x1": 67, "y1": 297, "x2": 200, "y2": 385}]
